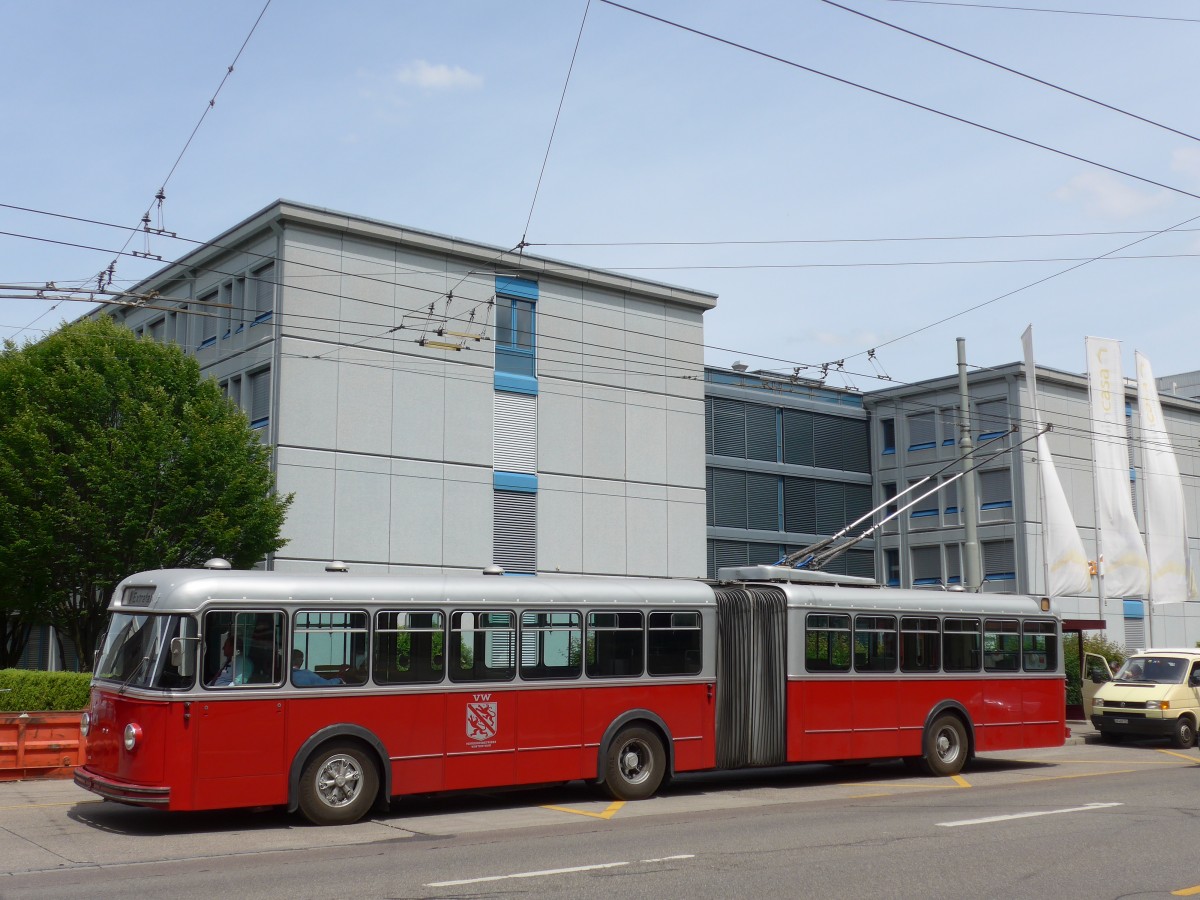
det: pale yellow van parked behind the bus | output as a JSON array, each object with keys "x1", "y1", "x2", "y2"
[{"x1": 1087, "y1": 648, "x2": 1200, "y2": 749}]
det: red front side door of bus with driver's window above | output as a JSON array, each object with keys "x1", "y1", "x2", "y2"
[{"x1": 198, "y1": 610, "x2": 287, "y2": 809}]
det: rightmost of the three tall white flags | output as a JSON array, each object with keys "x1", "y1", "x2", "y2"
[{"x1": 1134, "y1": 352, "x2": 1189, "y2": 604}]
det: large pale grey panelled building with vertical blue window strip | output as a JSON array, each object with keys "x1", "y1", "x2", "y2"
[{"x1": 96, "y1": 200, "x2": 716, "y2": 577}]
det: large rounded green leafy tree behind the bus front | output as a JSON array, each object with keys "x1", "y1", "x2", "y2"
[{"x1": 0, "y1": 318, "x2": 292, "y2": 667}]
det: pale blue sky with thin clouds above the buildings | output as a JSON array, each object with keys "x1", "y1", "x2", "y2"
[{"x1": 0, "y1": 0, "x2": 1200, "y2": 391}]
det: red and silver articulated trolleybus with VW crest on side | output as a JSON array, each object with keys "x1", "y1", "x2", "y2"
[{"x1": 76, "y1": 560, "x2": 1066, "y2": 824}]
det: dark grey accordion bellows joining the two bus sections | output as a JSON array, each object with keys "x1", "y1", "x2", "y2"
[{"x1": 714, "y1": 588, "x2": 787, "y2": 769}]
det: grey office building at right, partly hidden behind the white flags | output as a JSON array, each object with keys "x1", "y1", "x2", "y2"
[{"x1": 865, "y1": 364, "x2": 1200, "y2": 648}]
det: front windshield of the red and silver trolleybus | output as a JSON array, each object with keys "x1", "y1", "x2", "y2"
[{"x1": 95, "y1": 612, "x2": 197, "y2": 690}]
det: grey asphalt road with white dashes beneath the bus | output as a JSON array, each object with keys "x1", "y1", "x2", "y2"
[{"x1": 0, "y1": 744, "x2": 1200, "y2": 900}]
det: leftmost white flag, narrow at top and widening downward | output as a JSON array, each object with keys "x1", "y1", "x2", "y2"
[{"x1": 1021, "y1": 325, "x2": 1092, "y2": 596}]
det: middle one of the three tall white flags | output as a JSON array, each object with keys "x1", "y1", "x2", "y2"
[{"x1": 1086, "y1": 337, "x2": 1150, "y2": 598}]
